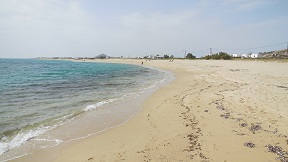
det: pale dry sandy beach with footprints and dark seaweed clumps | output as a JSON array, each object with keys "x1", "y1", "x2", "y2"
[{"x1": 15, "y1": 59, "x2": 288, "y2": 162}]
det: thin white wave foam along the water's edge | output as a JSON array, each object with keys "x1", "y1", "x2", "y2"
[{"x1": 0, "y1": 64, "x2": 173, "y2": 161}]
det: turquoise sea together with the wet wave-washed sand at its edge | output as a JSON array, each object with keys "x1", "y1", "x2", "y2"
[{"x1": 0, "y1": 59, "x2": 168, "y2": 161}]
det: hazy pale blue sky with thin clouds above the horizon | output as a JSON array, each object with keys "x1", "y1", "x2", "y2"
[{"x1": 0, "y1": 0, "x2": 288, "y2": 58}]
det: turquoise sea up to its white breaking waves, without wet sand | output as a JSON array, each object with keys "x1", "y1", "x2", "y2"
[{"x1": 0, "y1": 59, "x2": 169, "y2": 159}]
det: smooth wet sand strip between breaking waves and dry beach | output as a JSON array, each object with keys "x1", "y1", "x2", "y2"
[{"x1": 0, "y1": 59, "x2": 173, "y2": 161}]
